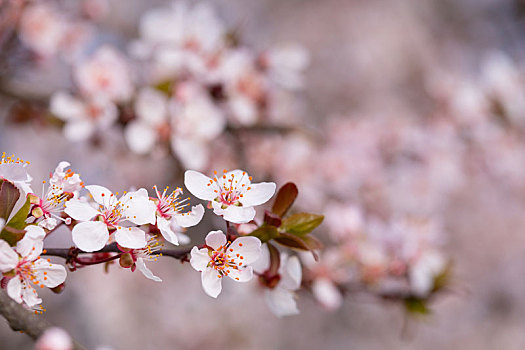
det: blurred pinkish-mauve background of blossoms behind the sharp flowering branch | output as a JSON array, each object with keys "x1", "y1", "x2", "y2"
[{"x1": 0, "y1": 0, "x2": 525, "y2": 350}]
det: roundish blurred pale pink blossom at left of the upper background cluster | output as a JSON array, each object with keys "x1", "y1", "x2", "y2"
[{"x1": 74, "y1": 46, "x2": 133, "y2": 102}]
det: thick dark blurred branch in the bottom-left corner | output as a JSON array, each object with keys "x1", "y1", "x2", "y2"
[{"x1": 0, "y1": 289, "x2": 84, "y2": 350}]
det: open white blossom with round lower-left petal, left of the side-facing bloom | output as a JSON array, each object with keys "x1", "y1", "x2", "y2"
[{"x1": 65, "y1": 185, "x2": 157, "y2": 252}]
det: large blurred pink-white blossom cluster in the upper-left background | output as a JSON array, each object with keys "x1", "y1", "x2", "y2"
[{"x1": 13, "y1": 2, "x2": 308, "y2": 170}]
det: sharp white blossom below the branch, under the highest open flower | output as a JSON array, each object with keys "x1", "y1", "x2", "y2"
[{"x1": 190, "y1": 231, "x2": 261, "y2": 298}]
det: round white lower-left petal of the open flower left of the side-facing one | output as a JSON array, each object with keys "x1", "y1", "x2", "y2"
[{"x1": 72, "y1": 221, "x2": 109, "y2": 252}]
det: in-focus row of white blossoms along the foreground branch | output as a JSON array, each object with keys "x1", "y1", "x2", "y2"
[{"x1": 0, "y1": 154, "x2": 320, "y2": 316}]
